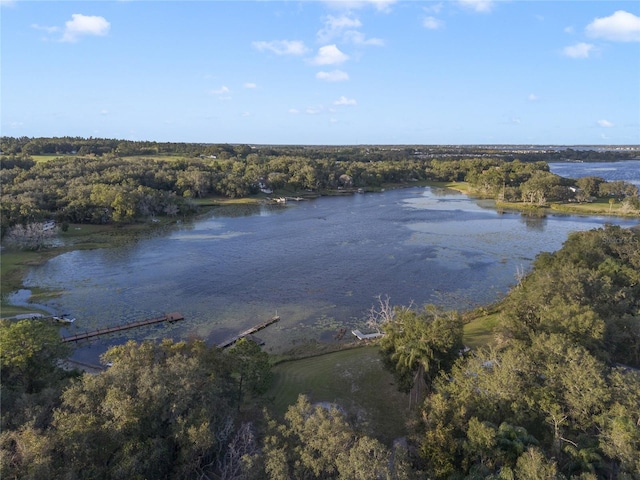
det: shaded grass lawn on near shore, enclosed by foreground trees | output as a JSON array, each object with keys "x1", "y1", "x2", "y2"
[{"x1": 267, "y1": 346, "x2": 409, "y2": 444}]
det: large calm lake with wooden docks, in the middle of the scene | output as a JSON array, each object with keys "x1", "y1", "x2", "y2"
[{"x1": 12, "y1": 159, "x2": 639, "y2": 360}]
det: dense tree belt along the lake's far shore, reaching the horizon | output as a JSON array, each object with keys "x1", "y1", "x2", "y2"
[{"x1": 0, "y1": 137, "x2": 640, "y2": 242}]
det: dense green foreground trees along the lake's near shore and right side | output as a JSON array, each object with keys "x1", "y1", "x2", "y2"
[{"x1": 0, "y1": 226, "x2": 640, "y2": 480}]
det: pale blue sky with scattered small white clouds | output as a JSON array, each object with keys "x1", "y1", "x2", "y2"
[{"x1": 0, "y1": 0, "x2": 640, "y2": 145}]
